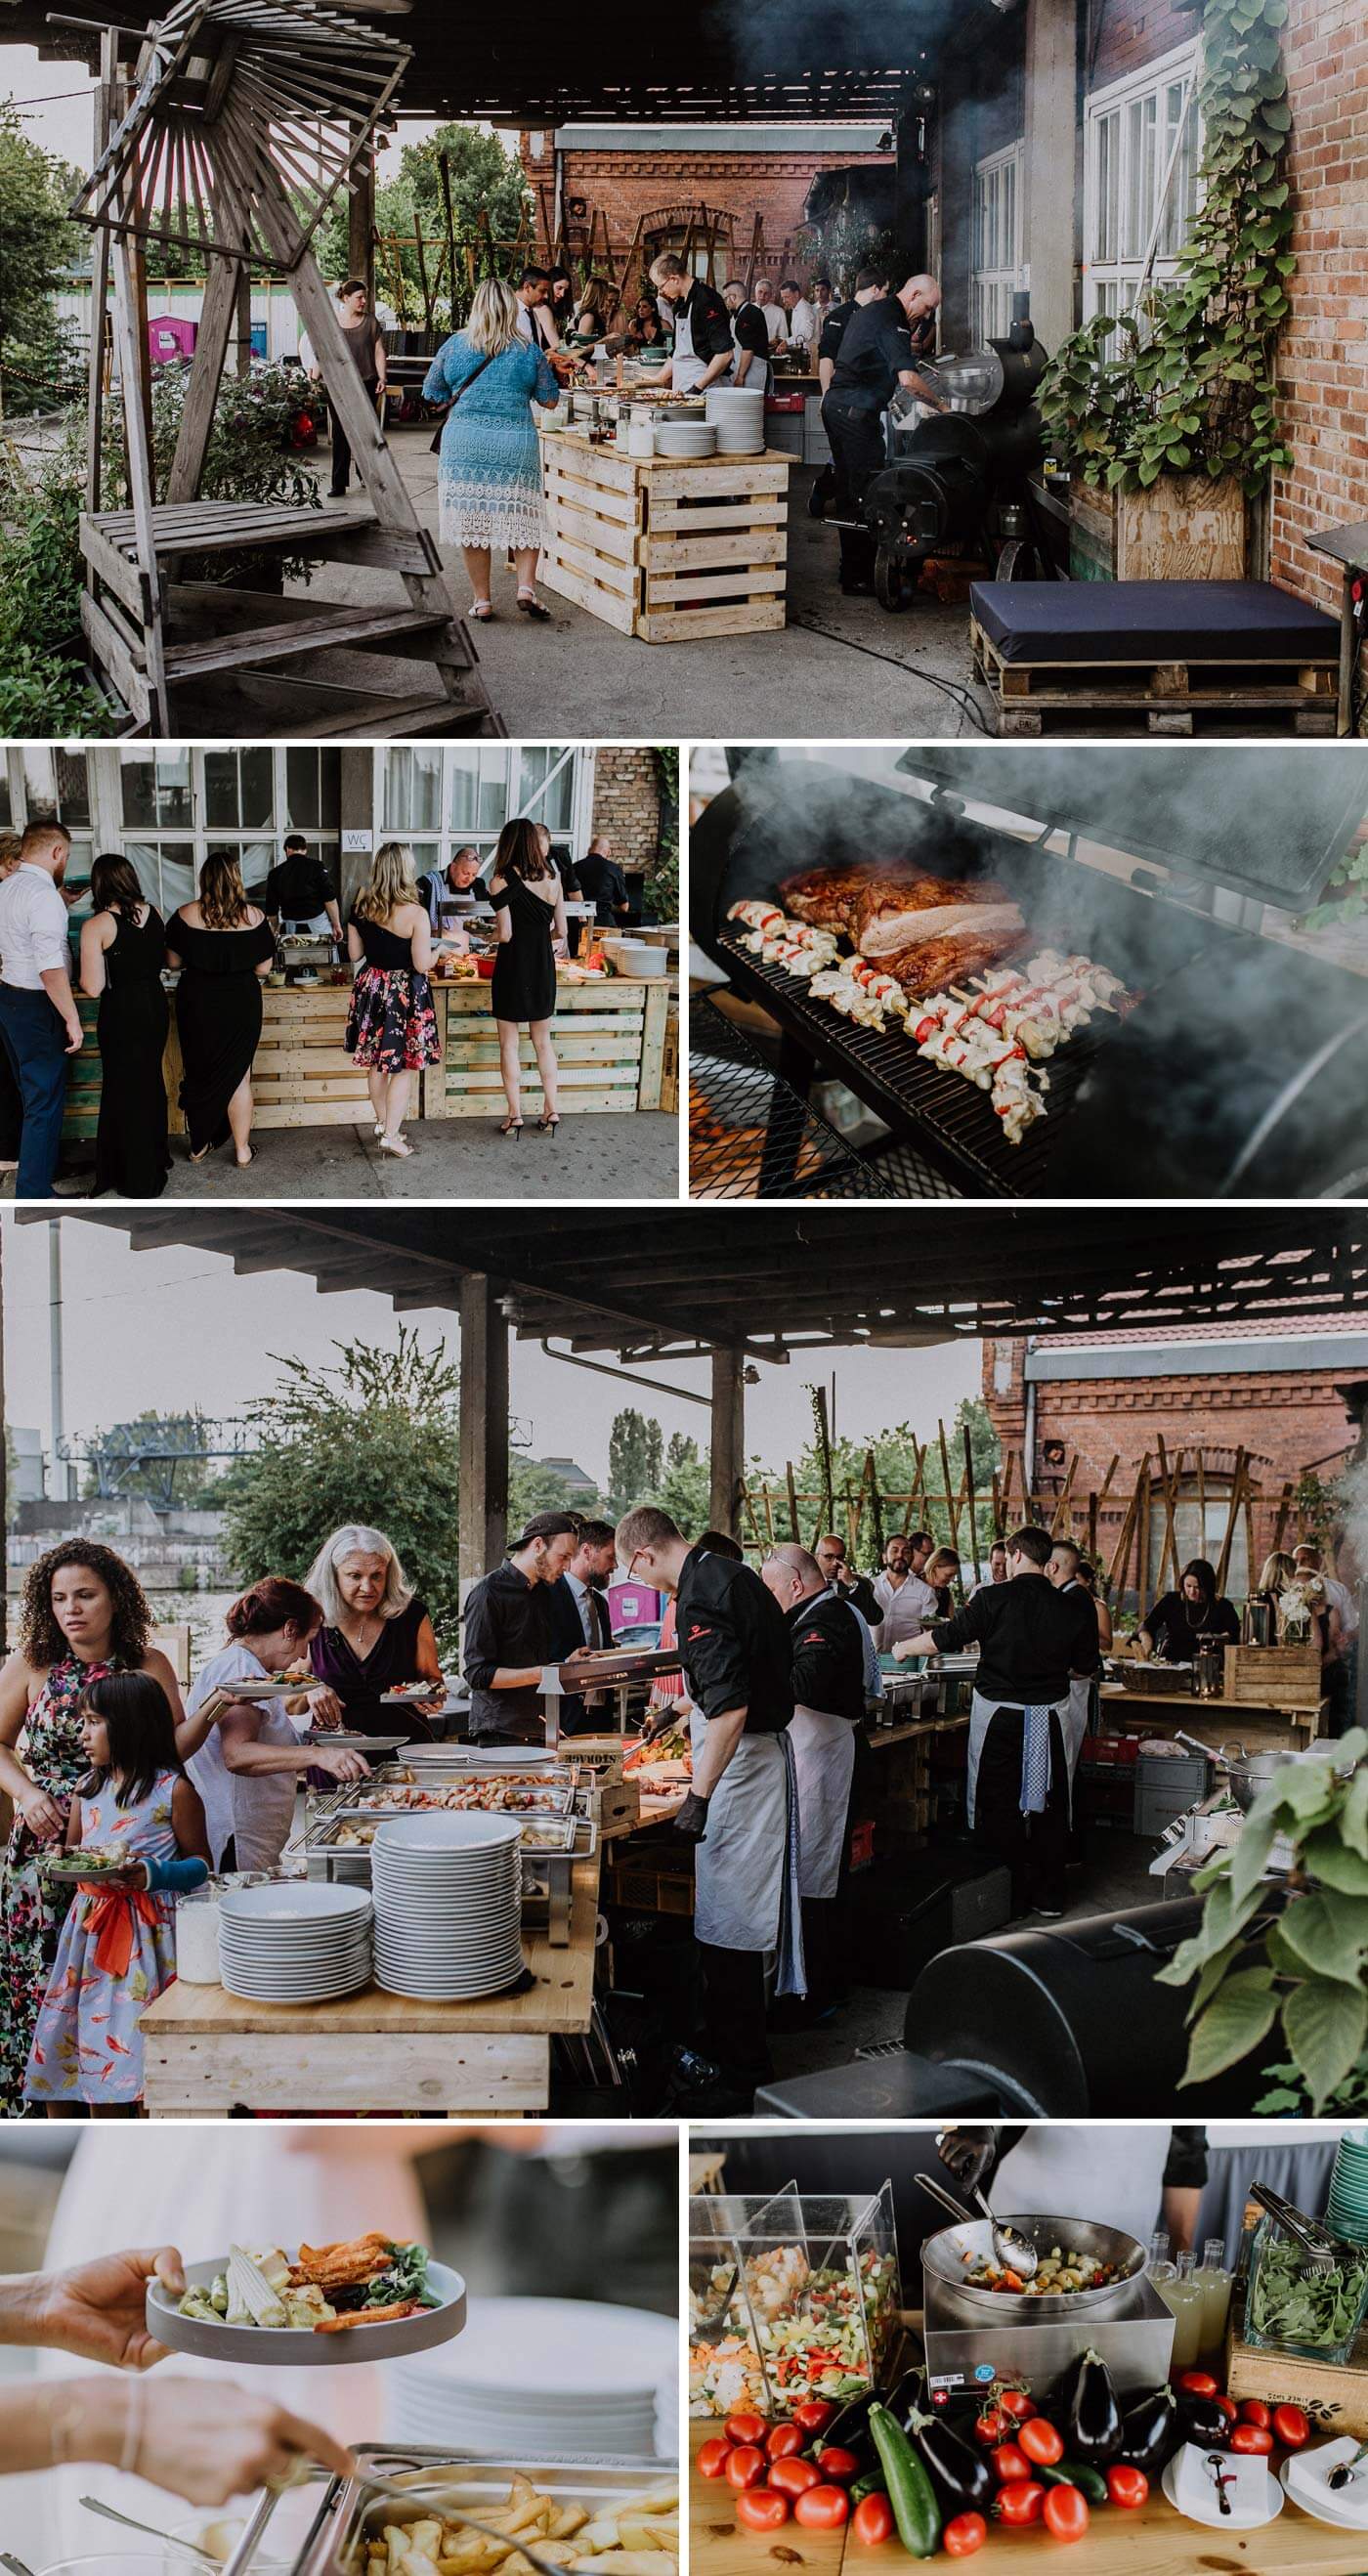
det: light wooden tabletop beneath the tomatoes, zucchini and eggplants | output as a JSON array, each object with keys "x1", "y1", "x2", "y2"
[{"x1": 688, "y1": 2422, "x2": 1368, "y2": 2576}]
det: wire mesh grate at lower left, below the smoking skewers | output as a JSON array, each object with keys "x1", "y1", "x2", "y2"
[{"x1": 688, "y1": 997, "x2": 894, "y2": 1198}]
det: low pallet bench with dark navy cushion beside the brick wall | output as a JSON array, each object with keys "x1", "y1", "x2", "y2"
[{"x1": 968, "y1": 582, "x2": 1340, "y2": 734}]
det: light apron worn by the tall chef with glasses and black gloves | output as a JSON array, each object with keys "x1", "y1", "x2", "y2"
[{"x1": 691, "y1": 1708, "x2": 806, "y2": 1994}]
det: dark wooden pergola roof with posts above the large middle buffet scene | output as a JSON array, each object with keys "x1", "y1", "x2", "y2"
[{"x1": 37, "y1": 1206, "x2": 1368, "y2": 1579}]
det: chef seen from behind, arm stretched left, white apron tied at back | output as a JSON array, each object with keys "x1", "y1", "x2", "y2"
[{"x1": 894, "y1": 1527, "x2": 1097, "y2": 1916}]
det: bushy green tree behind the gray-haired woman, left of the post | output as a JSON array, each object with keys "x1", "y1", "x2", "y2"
[{"x1": 222, "y1": 1327, "x2": 461, "y2": 1652}]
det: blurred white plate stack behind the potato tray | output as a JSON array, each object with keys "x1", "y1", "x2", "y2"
[{"x1": 384, "y1": 2297, "x2": 677, "y2": 2460}]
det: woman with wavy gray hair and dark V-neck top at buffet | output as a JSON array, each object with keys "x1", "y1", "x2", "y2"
[{"x1": 307, "y1": 1523, "x2": 446, "y2": 1737}]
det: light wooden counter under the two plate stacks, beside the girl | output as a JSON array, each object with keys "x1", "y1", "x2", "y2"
[{"x1": 142, "y1": 1852, "x2": 598, "y2": 2120}]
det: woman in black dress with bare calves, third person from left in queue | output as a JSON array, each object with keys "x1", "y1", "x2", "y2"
[{"x1": 167, "y1": 853, "x2": 276, "y2": 1172}]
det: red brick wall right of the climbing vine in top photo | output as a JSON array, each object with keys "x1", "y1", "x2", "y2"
[{"x1": 1272, "y1": 0, "x2": 1368, "y2": 608}]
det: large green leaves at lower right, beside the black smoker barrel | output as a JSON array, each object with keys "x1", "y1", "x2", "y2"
[{"x1": 1157, "y1": 1726, "x2": 1368, "y2": 2113}]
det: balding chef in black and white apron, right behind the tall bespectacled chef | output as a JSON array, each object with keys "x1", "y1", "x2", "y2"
[{"x1": 760, "y1": 1543, "x2": 878, "y2": 2012}]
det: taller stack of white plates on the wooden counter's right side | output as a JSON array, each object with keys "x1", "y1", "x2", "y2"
[{"x1": 371, "y1": 1808, "x2": 523, "y2": 2004}]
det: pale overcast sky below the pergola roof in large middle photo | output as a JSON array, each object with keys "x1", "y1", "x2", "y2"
[{"x1": 0, "y1": 1214, "x2": 979, "y2": 1481}]
